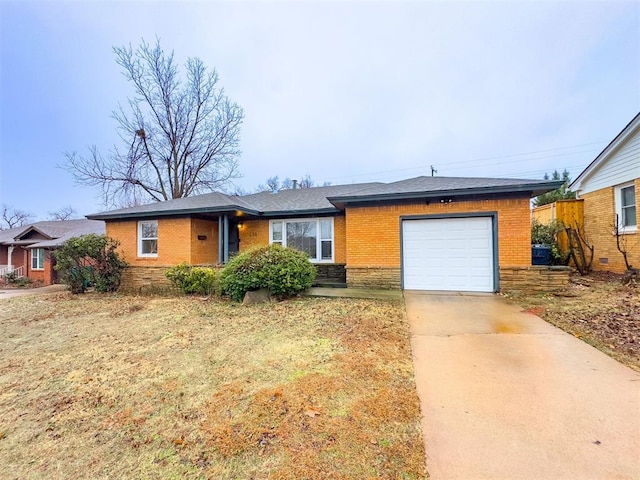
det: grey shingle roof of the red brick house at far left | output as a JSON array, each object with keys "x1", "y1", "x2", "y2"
[{"x1": 0, "y1": 219, "x2": 105, "y2": 248}]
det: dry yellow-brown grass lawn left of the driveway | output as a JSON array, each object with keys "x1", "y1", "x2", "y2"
[{"x1": 0, "y1": 293, "x2": 426, "y2": 479}]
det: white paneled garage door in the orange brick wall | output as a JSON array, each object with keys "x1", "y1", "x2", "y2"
[{"x1": 402, "y1": 217, "x2": 494, "y2": 292}]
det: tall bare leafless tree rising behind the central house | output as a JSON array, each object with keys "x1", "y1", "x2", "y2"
[{"x1": 65, "y1": 40, "x2": 244, "y2": 206}]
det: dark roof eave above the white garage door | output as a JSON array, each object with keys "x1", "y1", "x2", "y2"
[{"x1": 327, "y1": 180, "x2": 564, "y2": 207}]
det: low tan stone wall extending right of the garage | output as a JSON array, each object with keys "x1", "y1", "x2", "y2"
[{"x1": 500, "y1": 265, "x2": 571, "y2": 293}]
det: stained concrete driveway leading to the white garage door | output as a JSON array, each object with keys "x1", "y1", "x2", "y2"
[{"x1": 405, "y1": 292, "x2": 640, "y2": 480}]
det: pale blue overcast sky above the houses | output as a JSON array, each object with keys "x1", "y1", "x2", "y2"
[{"x1": 0, "y1": 0, "x2": 640, "y2": 220}]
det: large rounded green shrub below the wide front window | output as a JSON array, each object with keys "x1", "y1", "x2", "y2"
[{"x1": 220, "y1": 244, "x2": 316, "y2": 302}]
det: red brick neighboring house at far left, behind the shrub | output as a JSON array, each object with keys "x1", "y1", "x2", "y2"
[{"x1": 0, "y1": 219, "x2": 105, "y2": 285}]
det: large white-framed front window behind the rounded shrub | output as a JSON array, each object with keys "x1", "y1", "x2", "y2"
[{"x1": 270, "y1": 218, "x2": 333, "y2": 262}]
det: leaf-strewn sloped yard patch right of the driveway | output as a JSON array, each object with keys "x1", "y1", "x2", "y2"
[{"x1": 511, "y1": 272, "x2": 640, "y2": 371}]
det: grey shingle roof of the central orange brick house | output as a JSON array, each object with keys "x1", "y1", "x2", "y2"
[{"x1": 87, "y1": 177, "x2": 562, "y2": 220}]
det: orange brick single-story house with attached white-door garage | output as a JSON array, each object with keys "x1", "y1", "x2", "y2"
[{"x1": 88, "y1": 177, "x2": 562, "y2": 292}]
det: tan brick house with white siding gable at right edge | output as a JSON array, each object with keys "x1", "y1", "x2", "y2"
[{"x1": 570, "y1": 113, "x2": 640, "y2": 272}]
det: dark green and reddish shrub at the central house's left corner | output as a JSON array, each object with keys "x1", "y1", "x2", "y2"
[{"x1": 53, "y1": 234, "x2": 127, "y2": 293}]
